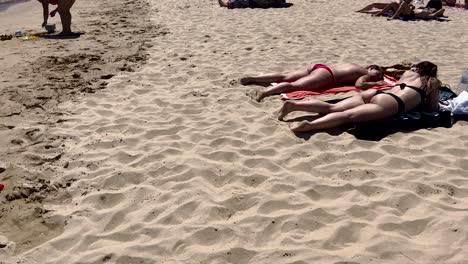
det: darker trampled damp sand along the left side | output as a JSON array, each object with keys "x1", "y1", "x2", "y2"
[{"x1": 0, "y1": 0, "x2": 157, "y2": 256}]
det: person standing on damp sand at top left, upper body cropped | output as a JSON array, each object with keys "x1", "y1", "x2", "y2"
[{"x1": 38, "y1": 0, "x2": 76, "y2": 36}]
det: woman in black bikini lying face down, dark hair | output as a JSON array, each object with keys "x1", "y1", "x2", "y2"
[{"x1": 278, "y1": 61, "x2": 441, "y2": 132}]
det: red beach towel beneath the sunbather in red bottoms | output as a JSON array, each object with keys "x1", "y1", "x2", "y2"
[{"x1": 281, "y1": 75, "x2": 397, "y2": 100}]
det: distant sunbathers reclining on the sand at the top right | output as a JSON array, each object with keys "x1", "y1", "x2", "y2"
[{"x1": 356, "y1": 0, "x2": 445, "y2": 19}]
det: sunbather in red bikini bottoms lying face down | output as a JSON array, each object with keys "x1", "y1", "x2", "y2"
[{"x1": 240, "y1": 63, "x2": 385, "y2": 102}]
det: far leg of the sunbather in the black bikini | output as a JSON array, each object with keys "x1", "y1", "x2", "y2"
[{"x1": 278, "y1": 89, "x2": 377, "y2": 120}]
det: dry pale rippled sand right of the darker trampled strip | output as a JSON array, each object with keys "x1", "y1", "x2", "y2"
[{"x1": 0, "y1": 0, "x2": 468, "y2": 264}]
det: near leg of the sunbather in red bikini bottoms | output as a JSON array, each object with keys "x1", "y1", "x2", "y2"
[{"x1": 257, "y1": 69, "x2": 334, "y2": 102}]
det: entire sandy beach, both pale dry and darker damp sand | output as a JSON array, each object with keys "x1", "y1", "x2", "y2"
[{"x1": 0, "y1": 0, "x2": 468, "y2": 264}]
